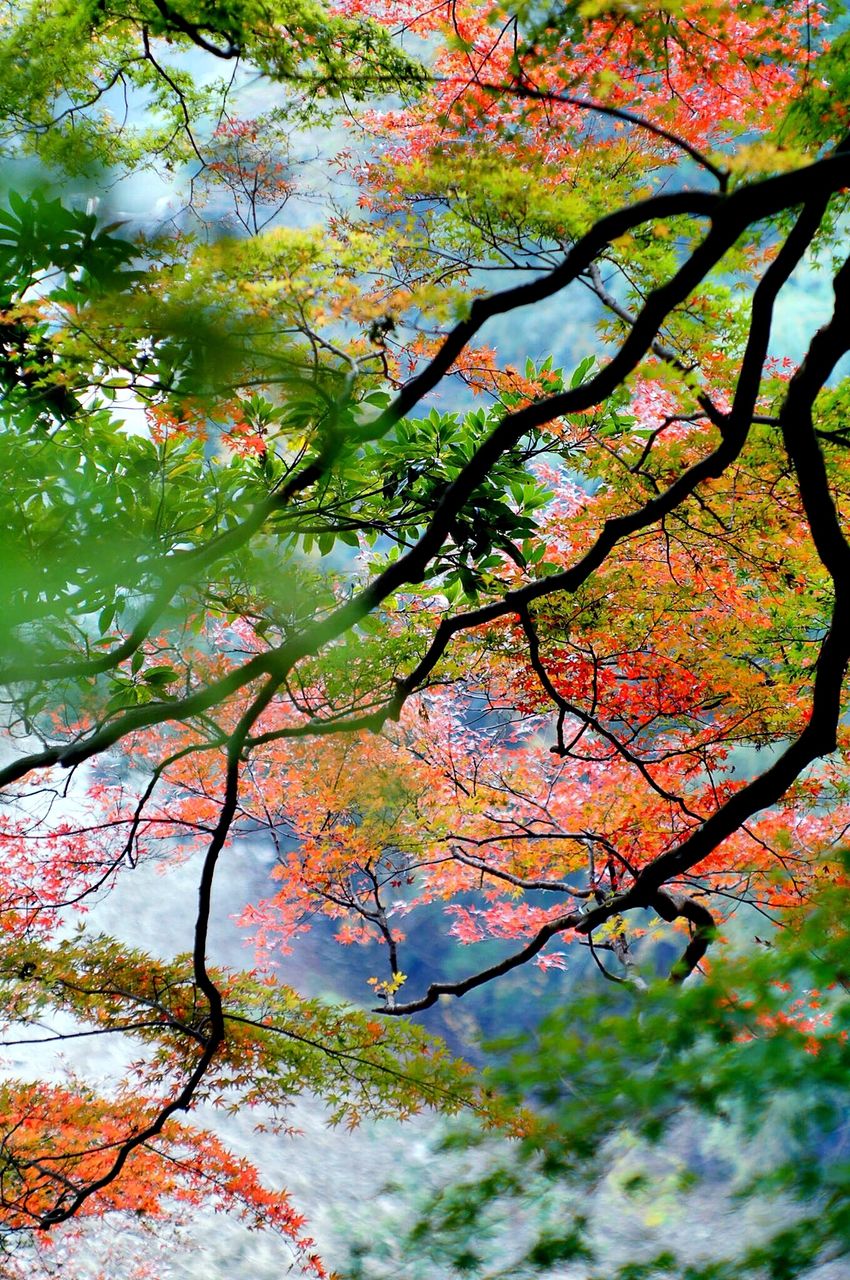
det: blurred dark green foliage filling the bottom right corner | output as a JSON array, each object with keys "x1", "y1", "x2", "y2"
[{"x1": 351, "y1": 886, "x2": 850, "y2": 1280}]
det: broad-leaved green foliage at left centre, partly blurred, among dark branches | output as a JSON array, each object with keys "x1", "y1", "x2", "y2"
[{"x1": 0, "y1": 186, "x2": 570, "y2": 691}]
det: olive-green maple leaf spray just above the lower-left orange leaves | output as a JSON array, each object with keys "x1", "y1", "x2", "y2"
[{"x1": 0, "y1": 931, "x2": 489, "y2": 1128}]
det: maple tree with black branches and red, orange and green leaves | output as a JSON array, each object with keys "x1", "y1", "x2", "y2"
[{"x1": 0, "y1": 0, "x2": 850, "y2": 1270}]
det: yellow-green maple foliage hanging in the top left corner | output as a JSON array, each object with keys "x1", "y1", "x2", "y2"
[{"x1": 0, "y1": 0, "x2": 422, "y2": 173}]
